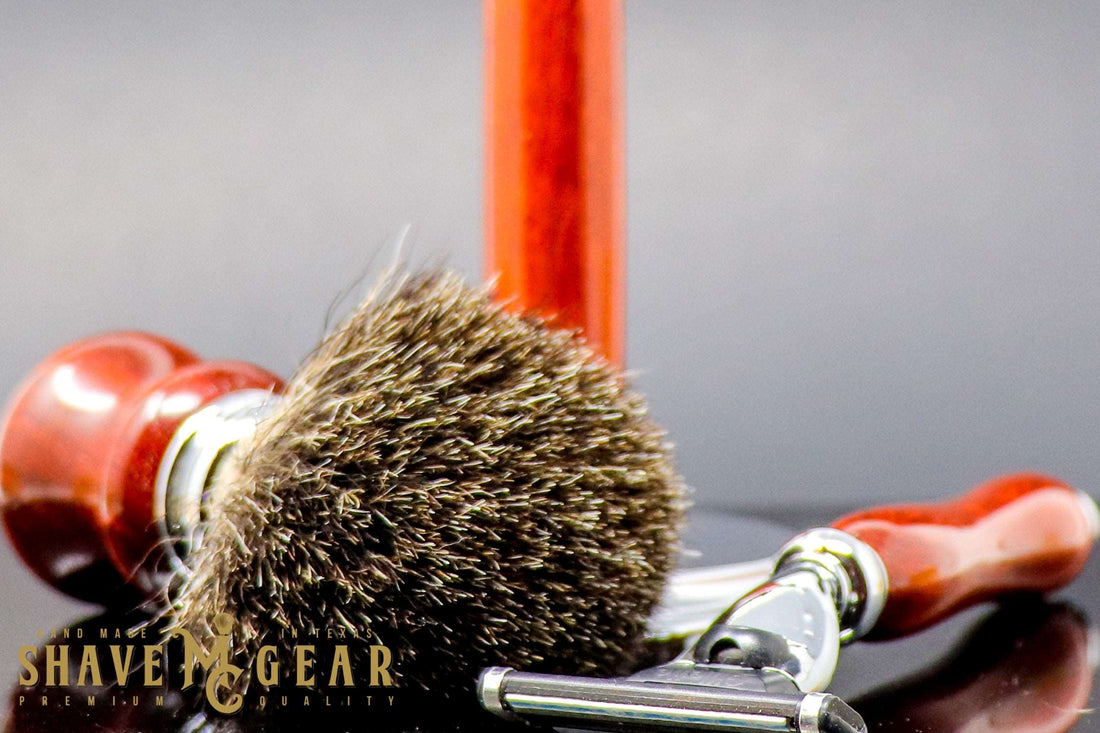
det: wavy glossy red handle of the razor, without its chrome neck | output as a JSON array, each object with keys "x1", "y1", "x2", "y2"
[{"x1": 833, "y1": 473, "x2": 1098, "y2": 638}]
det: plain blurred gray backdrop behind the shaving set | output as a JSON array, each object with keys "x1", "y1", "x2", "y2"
[{"x1": 0, "y1": 0, "x2": 1100, "y2": 519}]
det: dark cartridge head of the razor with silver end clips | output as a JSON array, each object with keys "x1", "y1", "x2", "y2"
[{"x1": 477, "y1": 663, "x2": 867, "y2": 733}]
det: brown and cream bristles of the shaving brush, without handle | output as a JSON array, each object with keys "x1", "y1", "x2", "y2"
[{"x1": 175, "y1": 273, "x2": 683, "y2": 694}]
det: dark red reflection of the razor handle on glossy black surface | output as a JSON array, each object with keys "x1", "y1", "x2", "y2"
[{"x1": 850, "y1": 601, "x2": 1097, "y2": 733}]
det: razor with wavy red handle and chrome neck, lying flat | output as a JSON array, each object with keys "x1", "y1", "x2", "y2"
[{"x1": 477, "y1": 473, "x2": 1100, "y2": 733}]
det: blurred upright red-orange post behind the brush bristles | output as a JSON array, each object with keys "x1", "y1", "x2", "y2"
[{"x1": 485, "y1": 0, "x2": 624, "y2": 363}]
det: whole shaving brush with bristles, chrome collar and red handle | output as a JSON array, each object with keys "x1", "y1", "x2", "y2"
[{"x1": 0, "y1": 264, "x2": 684, "y2": 717}]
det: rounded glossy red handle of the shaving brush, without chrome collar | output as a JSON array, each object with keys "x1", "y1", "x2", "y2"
[{"x1": 0, "y1": 332, "x2": 282, "y2": 602}]
